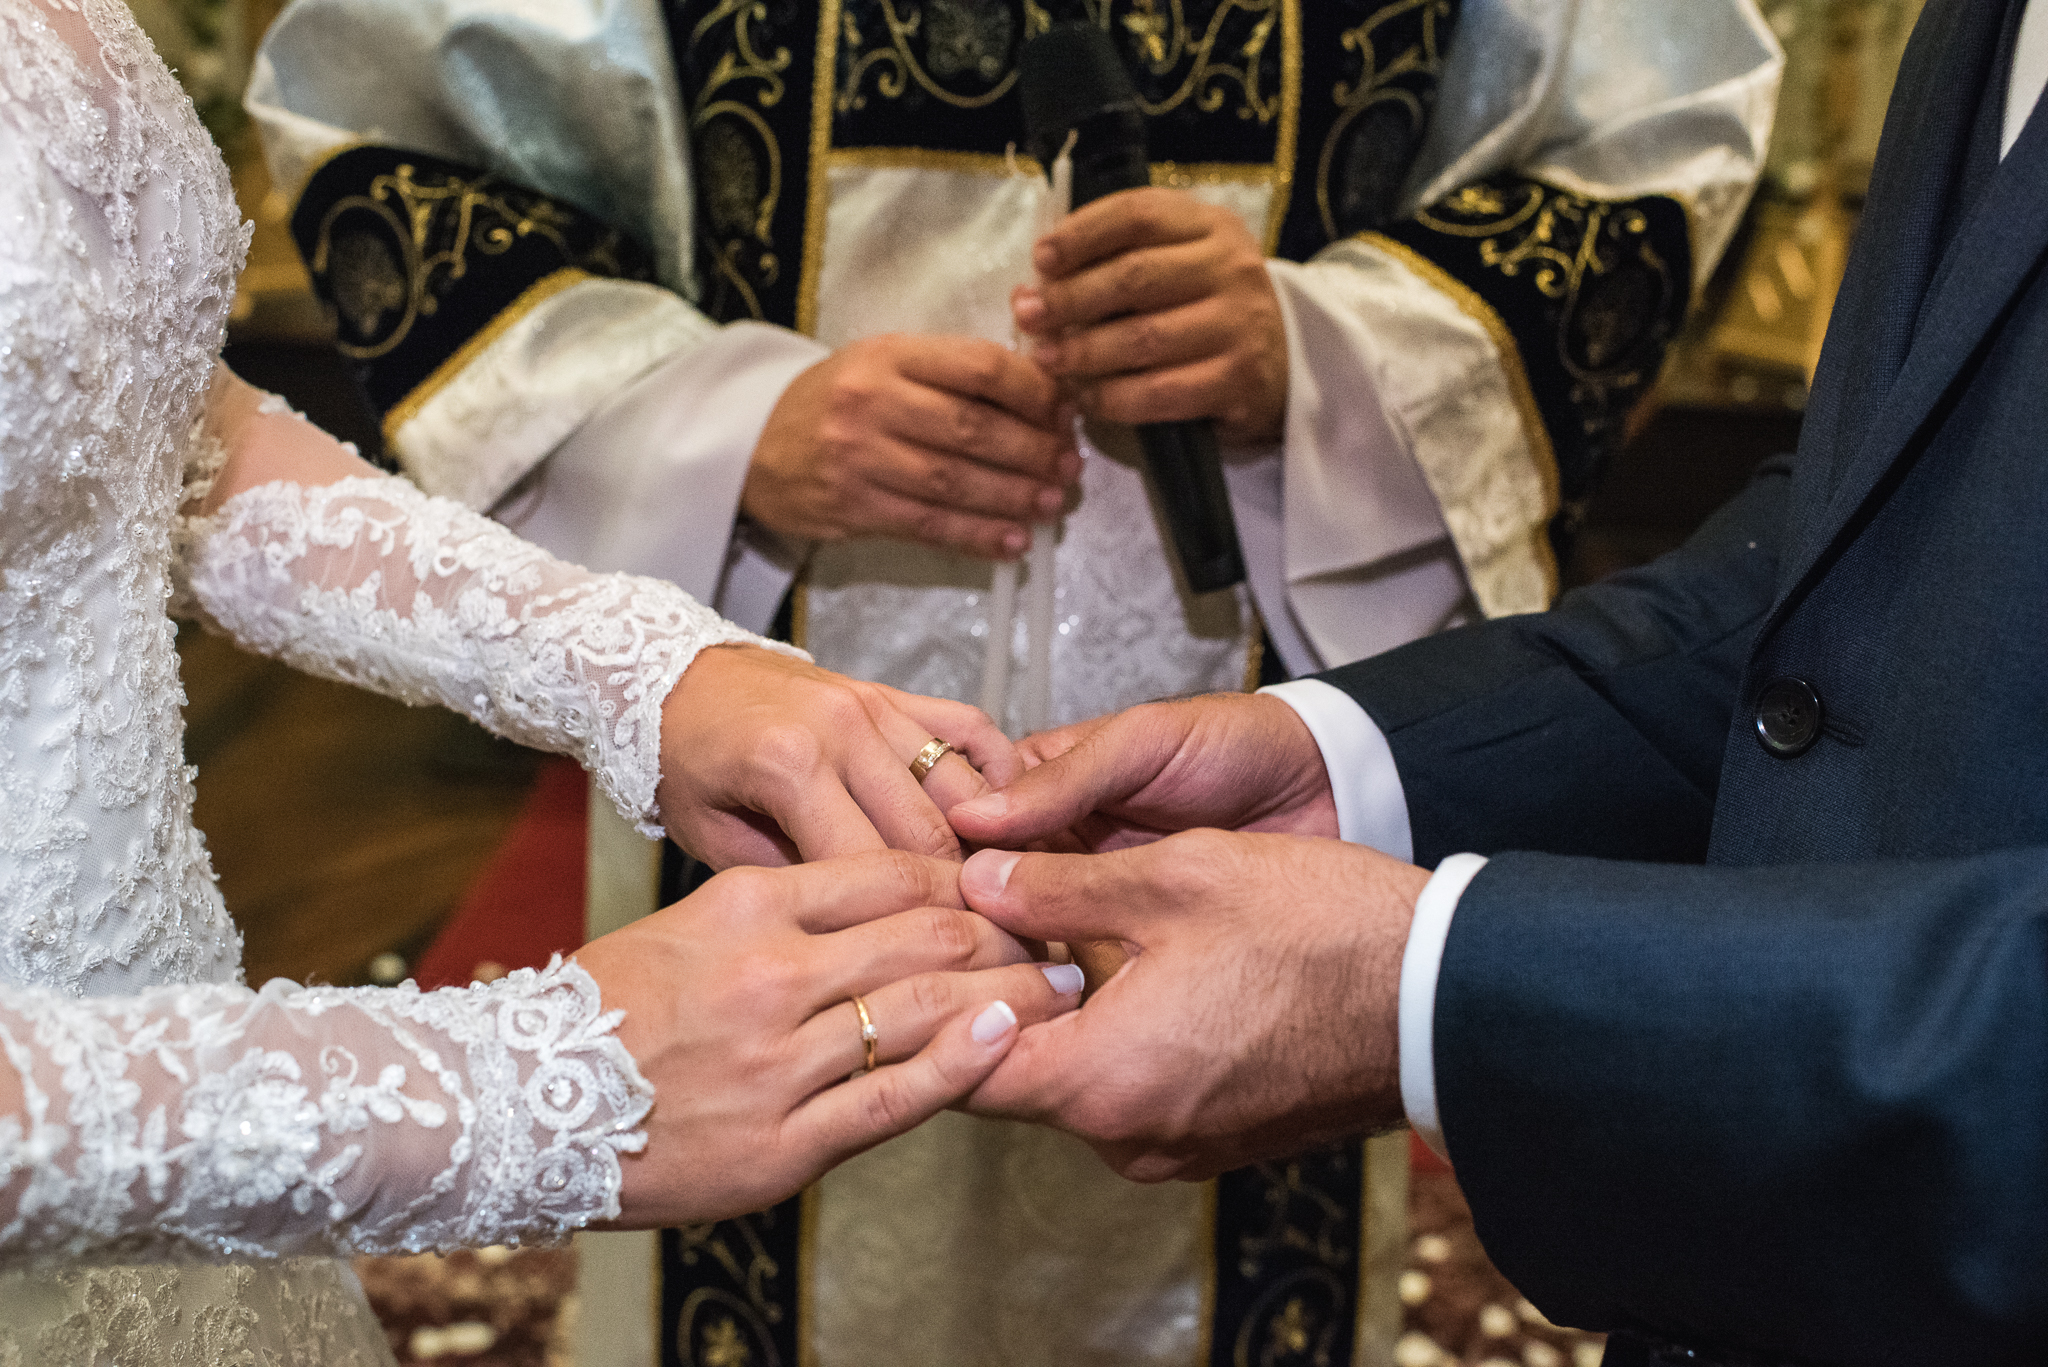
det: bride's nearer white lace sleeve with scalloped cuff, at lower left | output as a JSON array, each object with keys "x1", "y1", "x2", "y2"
[{"x1": 0, "y1": 959, "x2": 653, "y2": 1265}]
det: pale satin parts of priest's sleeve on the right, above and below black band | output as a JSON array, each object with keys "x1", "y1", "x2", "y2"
[{"x1": 1233, "y1": 0, "x2": 1782, "y2": 635}]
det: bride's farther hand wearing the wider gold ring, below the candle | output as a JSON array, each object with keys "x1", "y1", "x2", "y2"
[{"x1": 657, "y1": 646, "x2": 1020, "y2": 869}]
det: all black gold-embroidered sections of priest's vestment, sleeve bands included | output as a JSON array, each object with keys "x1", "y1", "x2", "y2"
[{"x1": 293, "y1": 0, "x2": 1690, "y2": 1367}]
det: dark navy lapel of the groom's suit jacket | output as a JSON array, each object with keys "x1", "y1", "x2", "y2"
[{"x1": 1774, "y1": 0, "x2": 2048, "y2": 621}]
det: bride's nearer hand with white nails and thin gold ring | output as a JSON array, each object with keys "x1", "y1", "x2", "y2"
[{"x1": 575, "y1": 853, "x2": 1081, "y2": 1228}]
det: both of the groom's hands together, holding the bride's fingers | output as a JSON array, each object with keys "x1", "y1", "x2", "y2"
[{"x1": 950, "y1": 695, "x2": 1430, "y2": 1180}]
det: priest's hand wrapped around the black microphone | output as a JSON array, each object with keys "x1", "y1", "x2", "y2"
[{"x1": 1010, "y1": 189, "x2": 1288, "y2": 443}]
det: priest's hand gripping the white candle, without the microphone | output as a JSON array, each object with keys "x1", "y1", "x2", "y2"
[{"x1": 739, "y1": 334, "x2": 1081, "y2": 560}]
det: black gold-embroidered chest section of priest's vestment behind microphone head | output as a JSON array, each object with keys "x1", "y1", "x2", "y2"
[{"x1": 668, "y1": 0, "x2": 1458, "y2": 328}]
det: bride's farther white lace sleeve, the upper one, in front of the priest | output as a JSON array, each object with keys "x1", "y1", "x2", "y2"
[{"x1": 178, "y1": 411, "x2": 801, "y2": 836}]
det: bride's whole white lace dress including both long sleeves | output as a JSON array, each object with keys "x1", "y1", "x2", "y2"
[{"x1": 0, "y1": 0, "x2": 782, "y2": 1367}]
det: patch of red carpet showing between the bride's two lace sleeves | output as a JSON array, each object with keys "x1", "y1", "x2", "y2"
[{"x1": 412, "y1": 758, "x2": 590, "y2": 988}]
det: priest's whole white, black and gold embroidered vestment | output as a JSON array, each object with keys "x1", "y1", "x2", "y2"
[{"x1": 250, "y1": 0, "x2": 1780, "y2": 1365}]
